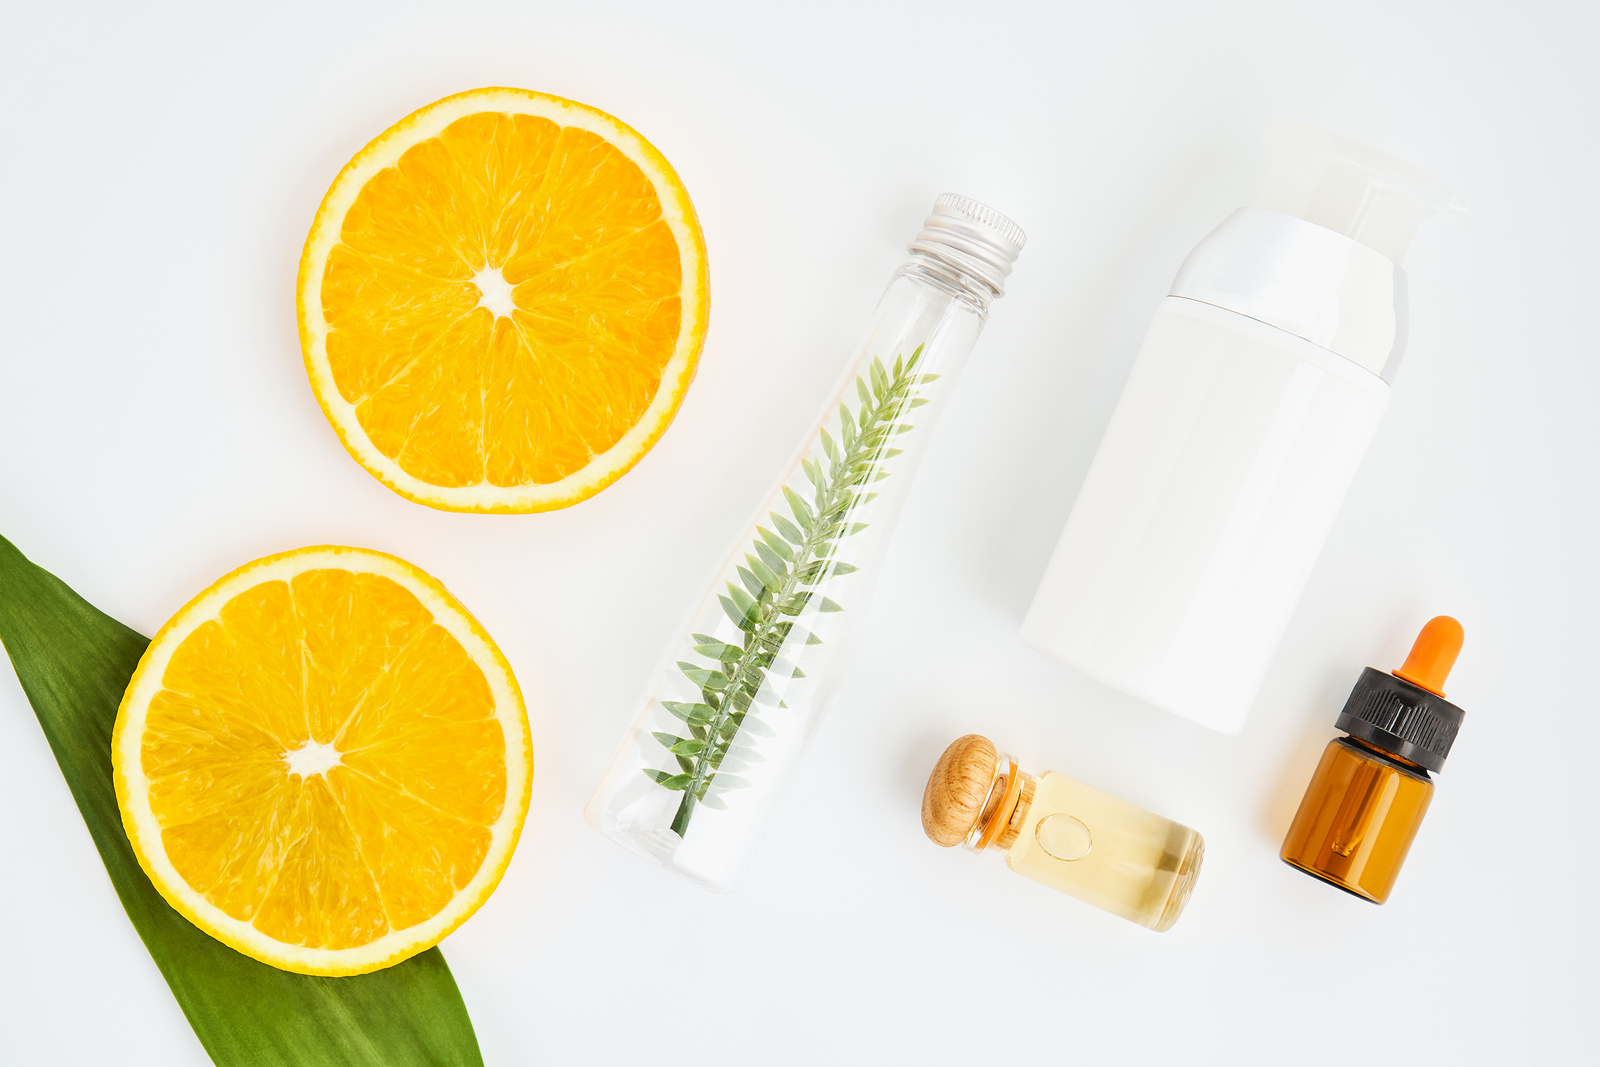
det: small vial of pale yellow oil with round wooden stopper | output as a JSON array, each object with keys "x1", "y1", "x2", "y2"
[{"x1": 922, "y1": 734, "x2": 1205, "y2": 933}]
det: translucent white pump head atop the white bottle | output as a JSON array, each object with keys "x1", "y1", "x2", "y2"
[{"x1": 1250, "y1": 123, "x2": 1467, "y2": 264}]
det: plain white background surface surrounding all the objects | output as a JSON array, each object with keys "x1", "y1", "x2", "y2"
[{"x1": 0, "y1": 0, "x2": 1600, "y2": 1065}]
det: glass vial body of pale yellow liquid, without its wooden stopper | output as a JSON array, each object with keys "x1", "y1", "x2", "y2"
[{"x1": 997, "y1": 771, "x2": 1205, "y2": 931}]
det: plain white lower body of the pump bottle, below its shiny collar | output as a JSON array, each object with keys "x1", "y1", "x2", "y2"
[{"x1": 1022, "y1": 298, "x2": 1389, "y2": 733}]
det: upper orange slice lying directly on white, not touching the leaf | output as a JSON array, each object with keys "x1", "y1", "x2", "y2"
[{"x1": 299, "y1": 88, "x2": 709, "y2": 512}]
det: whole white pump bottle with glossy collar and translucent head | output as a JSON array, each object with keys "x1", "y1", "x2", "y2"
[{"x1": 1022, "y1": 126, "x2": 1466, "y2": 733}]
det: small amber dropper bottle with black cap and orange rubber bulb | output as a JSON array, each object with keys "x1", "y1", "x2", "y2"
[{"x1": 1280, "y1": 616, "x2": 1466, "y2": 904}]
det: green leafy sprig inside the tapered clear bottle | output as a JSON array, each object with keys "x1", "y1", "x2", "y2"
[{"x1": 645, "y1": 346, "x2": 938, "y2": 837}]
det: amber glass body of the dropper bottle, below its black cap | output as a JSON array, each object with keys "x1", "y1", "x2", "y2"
[{"x1": 1278, "y1": 737, "x2": 1434, "y2": 904}]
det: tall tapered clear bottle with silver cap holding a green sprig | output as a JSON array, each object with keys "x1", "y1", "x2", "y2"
[{"x1": 584, "y1": 194, "x2": 1026, "y2": 891}]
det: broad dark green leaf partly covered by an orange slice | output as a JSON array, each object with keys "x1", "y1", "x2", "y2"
[{"x1": 0, "y1": 537, "x2": 483, "y2": 1067}]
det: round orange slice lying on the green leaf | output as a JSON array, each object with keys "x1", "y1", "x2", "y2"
[{"x1": 112, "y1": 547, "x2": 533, "y2": 974}]
